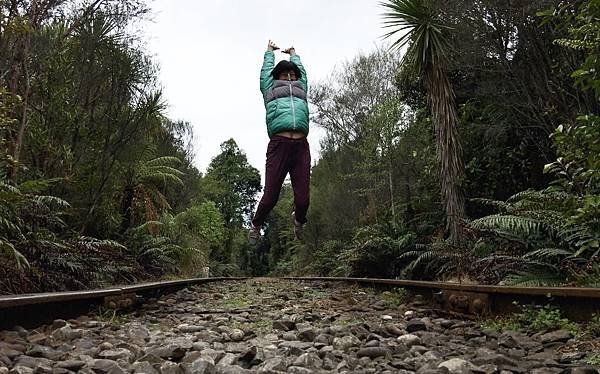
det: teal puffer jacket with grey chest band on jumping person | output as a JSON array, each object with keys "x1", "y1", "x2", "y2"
[{"x1": 260, "y1": 51, "x2": 308, "y2": 138}]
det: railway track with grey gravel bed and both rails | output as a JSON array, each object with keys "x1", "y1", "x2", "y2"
[{"x1": 0, "y1": 278, "x2": 600, "y2": 374}]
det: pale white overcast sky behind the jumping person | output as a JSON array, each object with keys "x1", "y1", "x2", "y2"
[{"x1": 145, "y1": 0, "x2": 383, "y2": 178}]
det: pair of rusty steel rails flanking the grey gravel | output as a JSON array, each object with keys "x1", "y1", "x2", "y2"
[{"x1": 0, "y1": 277, "x2": 600, "y2": 329}]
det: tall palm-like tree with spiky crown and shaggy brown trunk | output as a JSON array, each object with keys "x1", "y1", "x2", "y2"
[{"x1": 381, "y1": 0, "x2": 465, "y2": 243}]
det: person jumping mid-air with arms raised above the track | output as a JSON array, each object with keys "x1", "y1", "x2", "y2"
[{"x1": 248, "y1": 40, "x2": 310, "y2": 244}]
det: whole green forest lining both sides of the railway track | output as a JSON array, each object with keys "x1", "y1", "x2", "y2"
[{"x1": 0, "y1": 0, "x2": 600, "y2": 294}]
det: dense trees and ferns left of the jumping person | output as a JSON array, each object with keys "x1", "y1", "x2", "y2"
[{"x1": 0, "y1": 0, "x2": 260, "y2": 293}]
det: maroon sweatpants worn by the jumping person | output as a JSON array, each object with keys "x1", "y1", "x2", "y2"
[{"x1": 252, "y1": 135, "x2": 310, "y2": 227}]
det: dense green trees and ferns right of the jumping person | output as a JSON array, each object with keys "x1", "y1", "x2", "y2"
[{"x1": 253, "y1": 0, "x2": 600, "y2": 287}]
